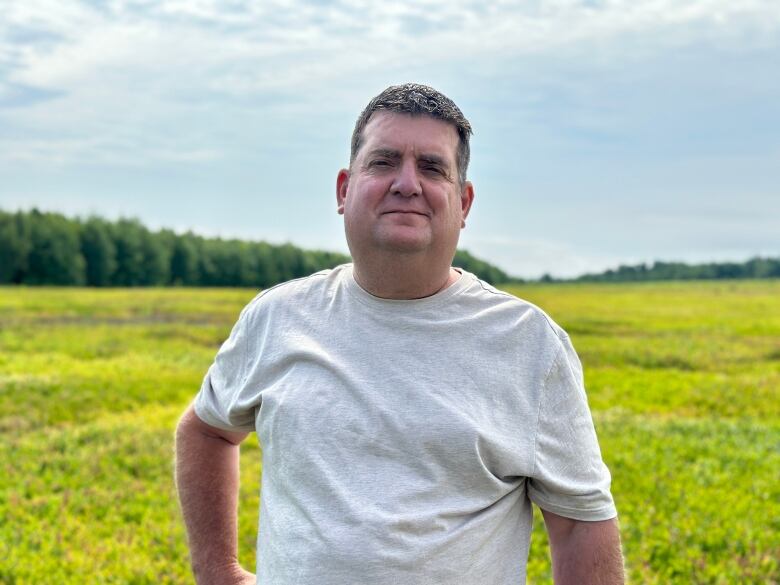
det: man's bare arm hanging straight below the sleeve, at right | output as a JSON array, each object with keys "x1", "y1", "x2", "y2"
[{"x1": 542, "y1": 510, "x2": 625, "y2": 585}]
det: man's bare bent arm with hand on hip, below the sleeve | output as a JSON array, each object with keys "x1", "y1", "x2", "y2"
[{"x1": 176, "y1": 406, "x2": 255, "y2": 585}]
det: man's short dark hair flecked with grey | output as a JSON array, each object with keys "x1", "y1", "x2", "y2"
[{"x1": 349, "y1": 83, "x2": 473, "y2": 185}]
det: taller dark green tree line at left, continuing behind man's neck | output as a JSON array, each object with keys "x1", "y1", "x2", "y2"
[{"x1": 0, "y1": 209, "x2": 511, "y2": 288}]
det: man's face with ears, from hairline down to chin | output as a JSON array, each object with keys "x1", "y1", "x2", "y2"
[{"x1": 336, "y1": 112, "x2": 474, "y2": 261}]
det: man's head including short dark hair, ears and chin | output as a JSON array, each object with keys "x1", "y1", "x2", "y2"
[{"x1": 336, "y1": 84, "x2": 474, "y2": 272}]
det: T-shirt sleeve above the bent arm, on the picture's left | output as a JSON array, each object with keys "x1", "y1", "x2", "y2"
[{"x1": 195, "y1": 305, "x2": 260, "y2": 432}]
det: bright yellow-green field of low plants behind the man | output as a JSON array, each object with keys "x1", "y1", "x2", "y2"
[{"x1": 0, "y1": 281, "x2": 780, "y2": 585}]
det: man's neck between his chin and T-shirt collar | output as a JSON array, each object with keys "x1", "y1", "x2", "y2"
[{"x1": 353, "y1": 257, "x2": 460, "y2": 300}]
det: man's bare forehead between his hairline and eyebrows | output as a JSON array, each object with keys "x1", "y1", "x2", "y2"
[{"x1": 358, "y1": 111, "x2": 459, "y2": 164}]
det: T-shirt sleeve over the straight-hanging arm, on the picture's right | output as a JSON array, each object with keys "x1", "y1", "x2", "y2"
[{"x1": 528, "y1": 337, "x2": 617, "y2": 521}]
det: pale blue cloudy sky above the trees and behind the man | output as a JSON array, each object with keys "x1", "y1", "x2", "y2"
[{"x1": 0, "y1": 0, "x2": 780, "y2": 278}]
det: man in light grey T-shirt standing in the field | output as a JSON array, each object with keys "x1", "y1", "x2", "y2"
[{"x1": 177, "y1": 84, "x2": 623, "y2": 585}]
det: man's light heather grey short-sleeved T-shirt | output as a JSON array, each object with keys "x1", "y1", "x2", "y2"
[{"x1": 195, "y1": 265, "x2": 616, "y2": 585}]
